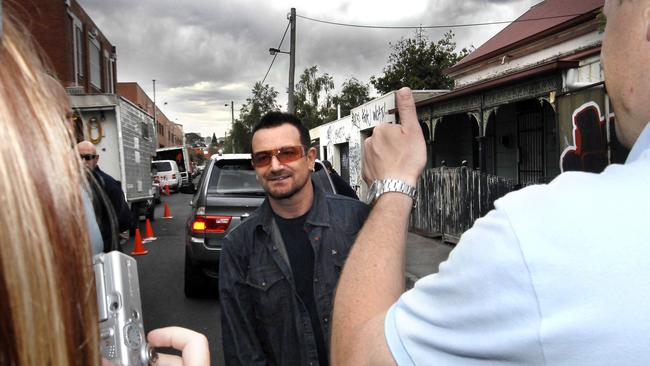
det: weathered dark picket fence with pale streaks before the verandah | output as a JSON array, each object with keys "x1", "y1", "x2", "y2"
[{"x1": 410, "y1": 167, "x2": 515, "y2": 243}]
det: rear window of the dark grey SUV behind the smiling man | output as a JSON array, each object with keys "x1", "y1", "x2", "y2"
[{"x1": 208, "y1": 159, "x2": 265, "y2": 195}]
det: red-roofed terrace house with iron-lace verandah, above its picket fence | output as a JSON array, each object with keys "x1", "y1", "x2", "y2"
[{"x1": 417, "y1": 0, "x2": 625, "y2": 186}]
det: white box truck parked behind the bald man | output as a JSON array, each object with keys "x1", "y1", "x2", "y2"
[{"x1": 69, "y1": 94, "x2": 157, "y2": 226}]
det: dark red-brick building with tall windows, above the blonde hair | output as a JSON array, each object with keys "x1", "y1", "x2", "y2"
[{"x1": 15, "y1": 0, "x2": 117, "y2": 94}]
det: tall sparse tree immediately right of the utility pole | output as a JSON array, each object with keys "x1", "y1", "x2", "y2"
[{"x1": 294, "y1": 65, "x2": 334, "y2": 129}]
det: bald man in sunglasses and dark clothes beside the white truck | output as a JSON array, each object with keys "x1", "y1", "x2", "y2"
[{"x1": 77, "y1": 141, "x2": 132, "y2": 252}]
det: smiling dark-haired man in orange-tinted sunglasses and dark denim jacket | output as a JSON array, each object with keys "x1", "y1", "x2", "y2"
[{"x1": 219, "y1": 112, "x2": 368, "y2": 365}]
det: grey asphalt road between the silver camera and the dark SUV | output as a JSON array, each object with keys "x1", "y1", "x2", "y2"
[{"x1": 124, "y1": 193, "x2": 224, "y2": 365}]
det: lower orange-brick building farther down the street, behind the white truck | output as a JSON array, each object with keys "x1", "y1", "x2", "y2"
[{"x1": 117, "y1": 82, "x2": 183, "y2": 148}]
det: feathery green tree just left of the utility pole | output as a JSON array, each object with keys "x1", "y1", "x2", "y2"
[{"x1": 224, "y1": 82, "x2": 280, "y2": 153}]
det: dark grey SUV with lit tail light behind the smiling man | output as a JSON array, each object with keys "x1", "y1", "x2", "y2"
[{"x1": 184, "y1": 154, "x2": 335, "y2": 297}]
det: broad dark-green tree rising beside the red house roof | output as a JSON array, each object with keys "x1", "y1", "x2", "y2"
[{"x1": 370, "y1": 28, "x2": 470, "y2": 94}]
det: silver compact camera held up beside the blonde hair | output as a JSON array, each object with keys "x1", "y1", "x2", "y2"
[{"x1": 93, "y1": 251, "x2": 158, "y2": 366}]
